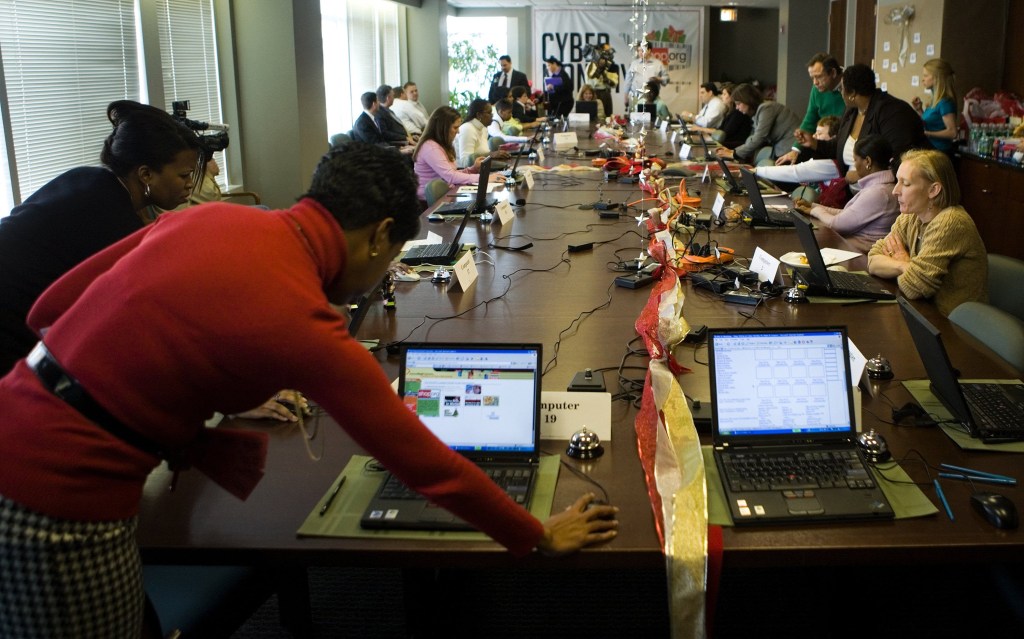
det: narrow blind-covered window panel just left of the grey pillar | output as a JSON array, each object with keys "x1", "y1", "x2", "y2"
[{"x1": 157, "y1": 0, "x2": 227, "y2": 187}]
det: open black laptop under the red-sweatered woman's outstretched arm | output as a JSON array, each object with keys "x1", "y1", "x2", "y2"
[{"x1": 359, "y1": 344, "x2": 543, "y2": 530}]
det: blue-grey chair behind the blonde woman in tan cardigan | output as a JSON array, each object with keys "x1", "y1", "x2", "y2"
[{"x1": 949, "y1": 253, "x2": 1024, "y2": 371}]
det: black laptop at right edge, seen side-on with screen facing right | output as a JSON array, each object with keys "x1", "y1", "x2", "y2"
[{"x1": 897, "y1": 297, "x2": 1024, "y2": 443}]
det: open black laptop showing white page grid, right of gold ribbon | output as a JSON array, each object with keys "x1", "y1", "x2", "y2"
[{"x1": 708, "y1": 327, "x2": 894, "y2": 526}]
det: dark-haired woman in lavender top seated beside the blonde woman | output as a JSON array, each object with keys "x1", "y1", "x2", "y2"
[{"x1": 790, "y1": 135, "x2": 899, "y2": 251}]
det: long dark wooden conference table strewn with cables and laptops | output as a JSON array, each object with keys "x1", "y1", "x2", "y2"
[{"x1": 138, "y1": 132, "x2": 1024, "y2": 630}]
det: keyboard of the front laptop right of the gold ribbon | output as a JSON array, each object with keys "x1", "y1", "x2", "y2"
[{"x1": 722, "y1": 451, "x2": 874, "y2": 492}]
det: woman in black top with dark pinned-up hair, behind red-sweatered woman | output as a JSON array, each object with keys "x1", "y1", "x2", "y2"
[{"x1": 0, "y1": 100, "x2": 206, "y2": 375}]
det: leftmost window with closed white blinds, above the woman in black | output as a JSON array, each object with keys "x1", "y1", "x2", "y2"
[{"x1": 0, "y1": 0, "x2": 142, "y2": 209}]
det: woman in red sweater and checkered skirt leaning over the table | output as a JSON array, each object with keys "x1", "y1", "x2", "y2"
[{"x1": 0, "y1": 142, "x2": 617, "y2": 639}]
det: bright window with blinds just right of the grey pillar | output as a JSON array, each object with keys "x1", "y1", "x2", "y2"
[{"x1": 321, "y1": 0, "x2": 401, "y2": 138}]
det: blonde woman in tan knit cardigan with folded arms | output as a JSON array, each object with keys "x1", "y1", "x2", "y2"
[{"x1": 867, "y1": 150, "x2": 988, "y2": 315}]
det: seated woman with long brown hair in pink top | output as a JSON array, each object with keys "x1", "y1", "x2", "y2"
[{"x1": 413, "y1": 107, "x2": 504, "y2": 201}]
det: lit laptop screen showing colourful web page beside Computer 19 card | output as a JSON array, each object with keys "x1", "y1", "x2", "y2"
[{"x1": 399, "y1": 344, "x2": 541, "y2": 456}]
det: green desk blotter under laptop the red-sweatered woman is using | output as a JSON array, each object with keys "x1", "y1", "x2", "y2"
[{"x1": 299, "y1": 455, "x2": 558, "y2": 542}]
